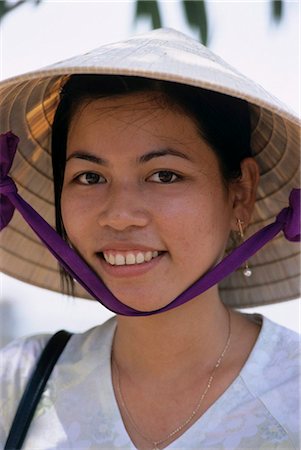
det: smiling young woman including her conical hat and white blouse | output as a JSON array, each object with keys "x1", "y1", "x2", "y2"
[{"x1": 0, "y1": 30, "x2": 299, "y2": 450}]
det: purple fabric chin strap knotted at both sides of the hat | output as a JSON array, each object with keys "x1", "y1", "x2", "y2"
[{"x1": 0, "y1": 132, "x2": 300, "y2": 316}]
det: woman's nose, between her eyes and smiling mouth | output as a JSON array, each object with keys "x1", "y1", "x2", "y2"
[{"x1": 98, "y1": 184, "x2": 151, "y2": 231}]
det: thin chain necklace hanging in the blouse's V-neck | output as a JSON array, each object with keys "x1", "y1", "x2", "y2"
[{"x1": 112, "y1": 309, "x2": 231, "y2": 450}]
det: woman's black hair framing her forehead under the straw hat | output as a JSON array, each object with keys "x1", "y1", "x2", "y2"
[{"x1": 52, "y1": 74, "x2": 252, "y2": 294}]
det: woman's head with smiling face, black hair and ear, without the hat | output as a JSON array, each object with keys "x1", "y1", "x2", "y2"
[{"x1": 52, "y1": 75, "x2": 258, "y2": 311}]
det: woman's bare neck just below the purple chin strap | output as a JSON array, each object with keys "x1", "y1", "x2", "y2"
[{"x1": 113, "y1": 289, "x2": 229, "y2": 379}]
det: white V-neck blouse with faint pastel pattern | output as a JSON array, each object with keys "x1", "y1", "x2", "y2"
[{"x1": 0, "y1": 316, "x2": 300, "y2": 450}]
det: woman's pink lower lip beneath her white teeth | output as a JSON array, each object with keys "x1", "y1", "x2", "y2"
[{"x1": 96, "y1": 251, "x2": 167, "y2": 278}]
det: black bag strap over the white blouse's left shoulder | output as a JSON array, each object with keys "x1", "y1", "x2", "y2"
[{"x1": 4, "y1": 330, "x2": 72, "y2": 450}]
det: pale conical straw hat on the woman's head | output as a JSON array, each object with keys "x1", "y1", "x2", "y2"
[{"x1": 0, "y1": 29, "x2": 300, "y2": 307}]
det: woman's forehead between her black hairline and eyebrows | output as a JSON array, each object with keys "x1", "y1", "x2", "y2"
[{"x1": 66, "y1": 93, "x2": 218, "y2": 178}]
